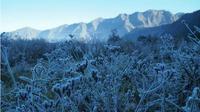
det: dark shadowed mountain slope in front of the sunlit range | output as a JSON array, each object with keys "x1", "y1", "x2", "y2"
[{"x1": 124, "y1": 10, "x2": 200, "y2": 40}]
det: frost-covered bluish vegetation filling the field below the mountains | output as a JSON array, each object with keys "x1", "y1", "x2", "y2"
[{"x1": 0, "y1": 18, "x2": 200, "y2": 112}]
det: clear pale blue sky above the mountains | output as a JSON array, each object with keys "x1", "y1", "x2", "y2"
[{"x1": 0, "y1": 0, "x2": 200, "y2": 32}]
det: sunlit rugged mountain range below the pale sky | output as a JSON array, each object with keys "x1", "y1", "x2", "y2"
[{"x1": 3, "y1": 10, "x2": 184, "y2": 42}]
